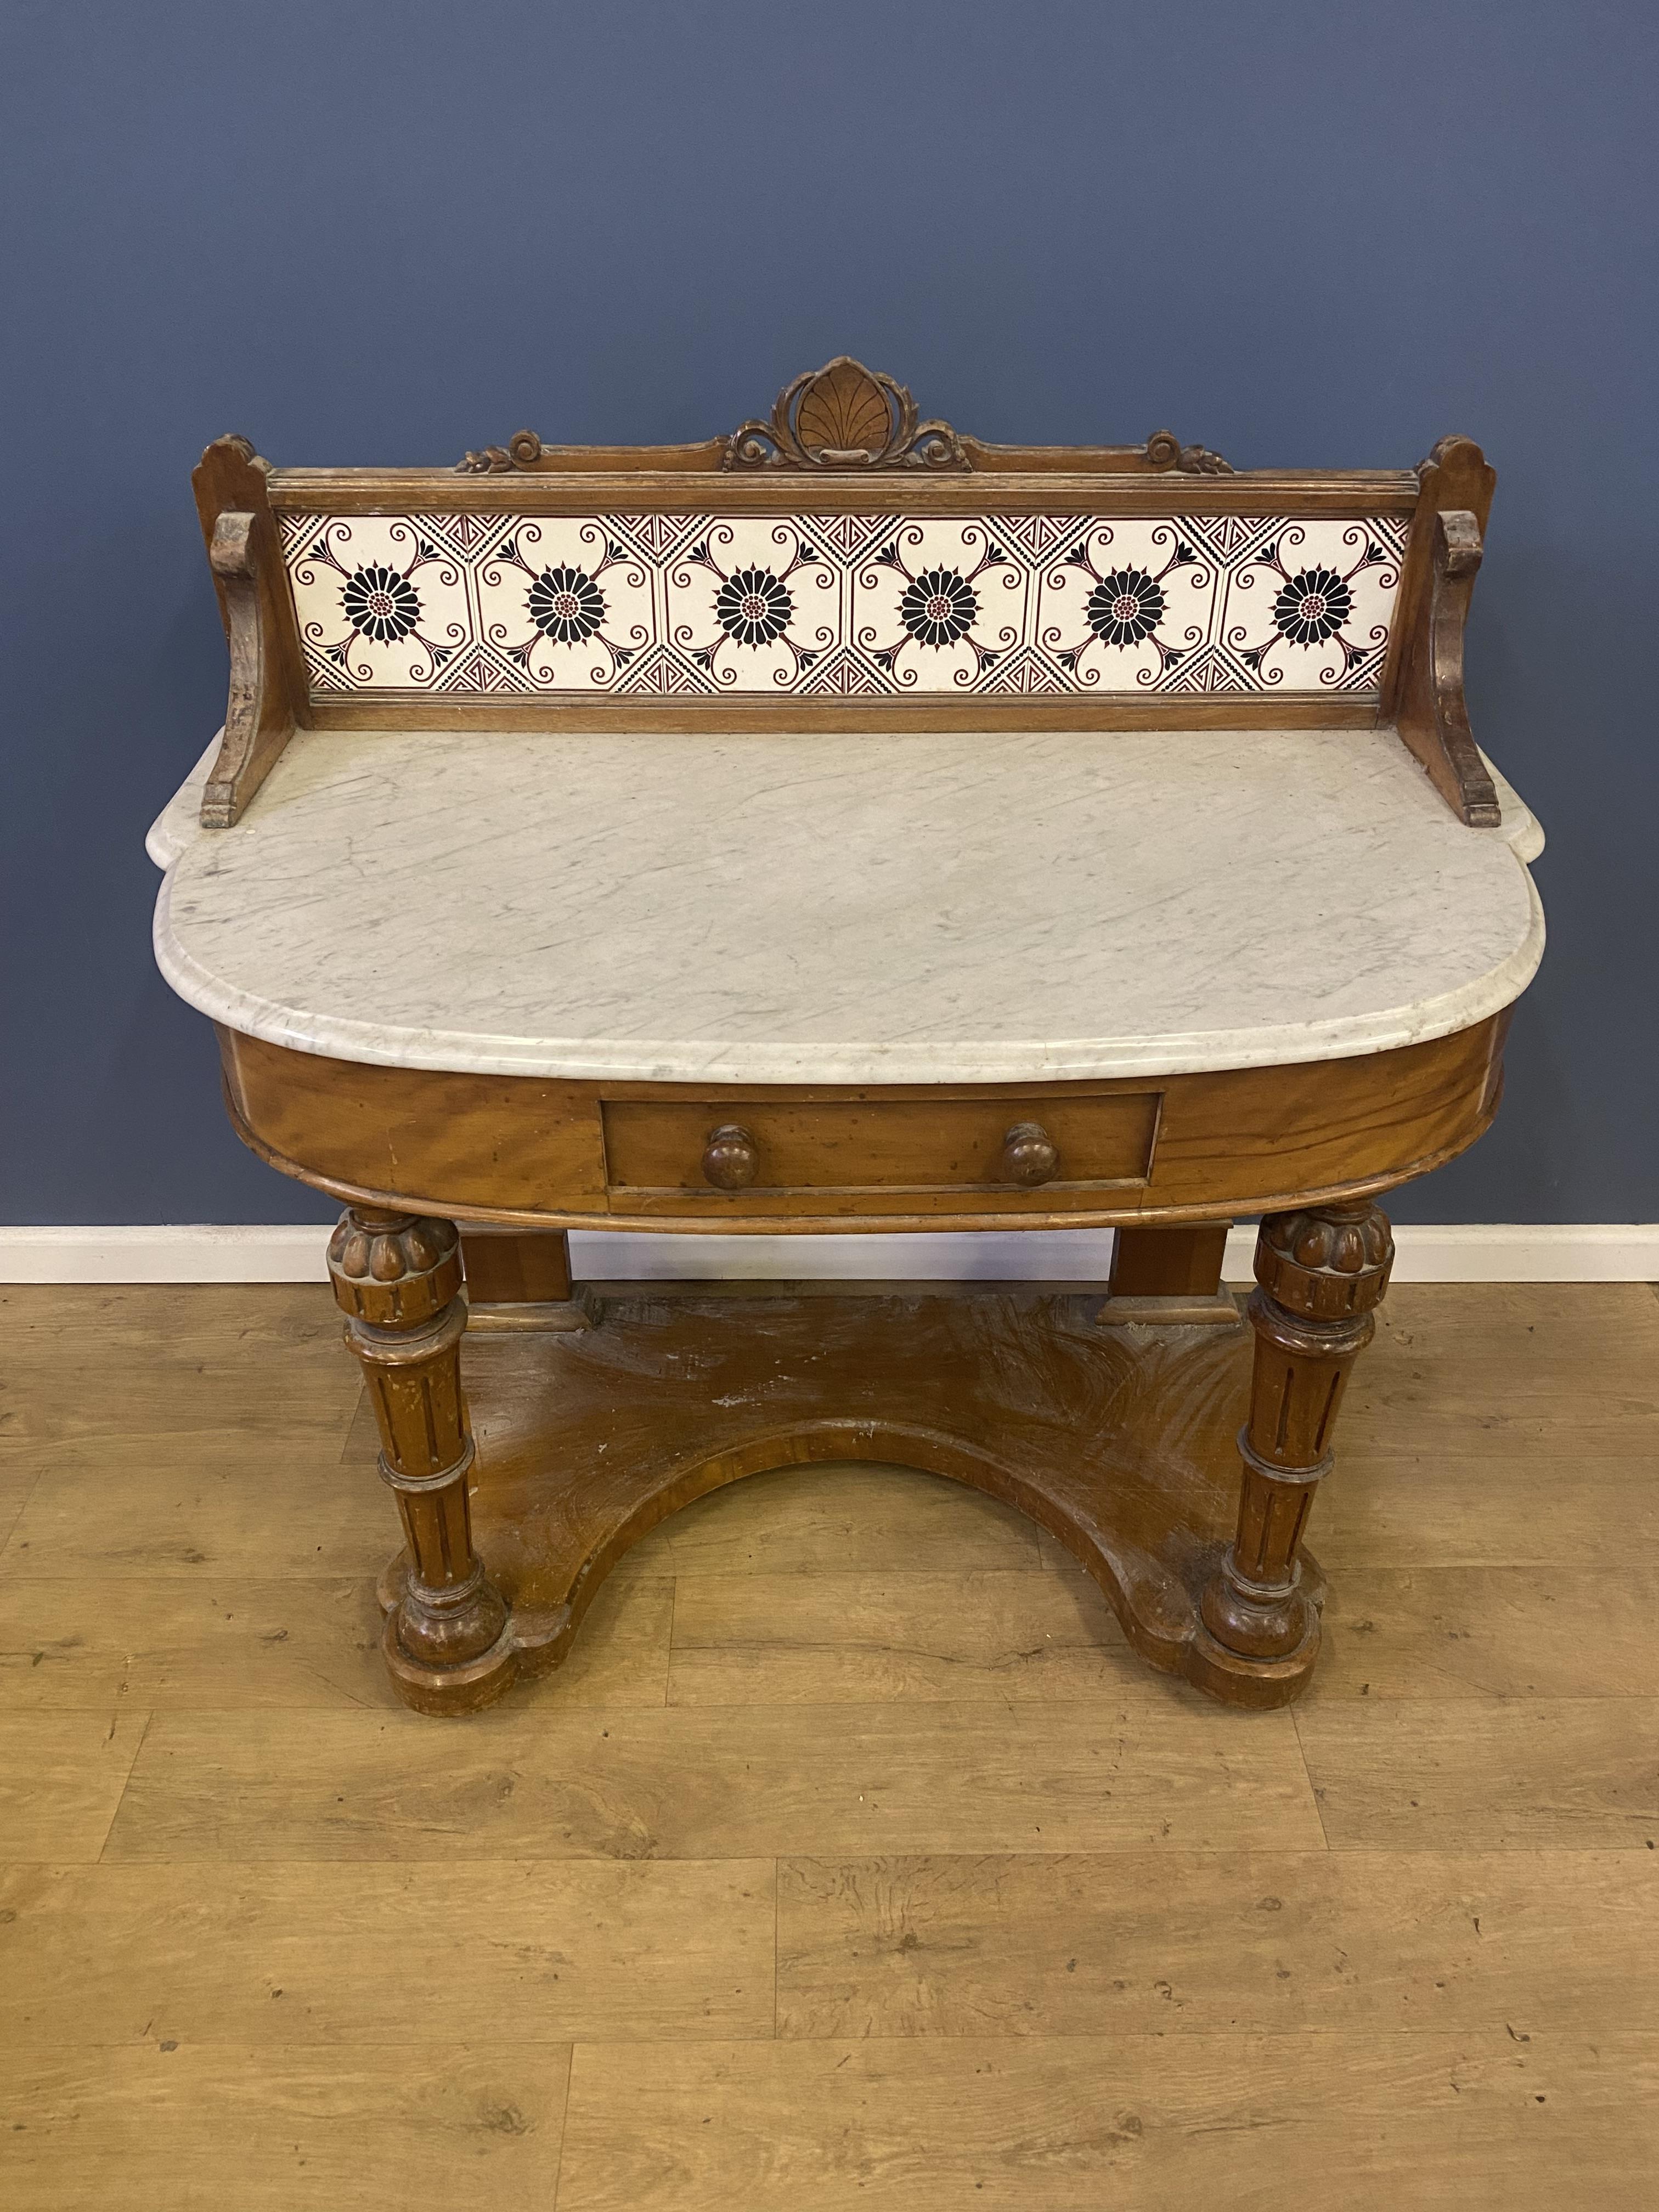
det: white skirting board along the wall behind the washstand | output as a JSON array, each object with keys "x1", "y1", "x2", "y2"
[{"x1": 0, "y1": 1221, "x2": 1659, "y2": 1283}]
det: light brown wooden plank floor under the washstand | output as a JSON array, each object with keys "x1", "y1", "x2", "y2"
[{"x1": 0, "y1": 1285, "x2": 1659, "y2": 2212}]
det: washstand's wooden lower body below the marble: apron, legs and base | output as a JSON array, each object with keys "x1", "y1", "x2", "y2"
[{"x1": 223, "y1": 1020, "x2": 1469, "y2": 1712}]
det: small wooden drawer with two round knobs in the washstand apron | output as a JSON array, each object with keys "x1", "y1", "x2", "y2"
[{"x1": 602, "y1": 1091, "x2": 1161, "y2": 1203}]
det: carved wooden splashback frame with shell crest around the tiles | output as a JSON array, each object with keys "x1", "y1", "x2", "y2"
[{"x1": 195, "y1": 356, "x2": 1496, "y2": 827}]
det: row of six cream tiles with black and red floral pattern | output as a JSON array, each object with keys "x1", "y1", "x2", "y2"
[{"x1": 279, "y1": 513, "x2": 1407, "y2": 699}]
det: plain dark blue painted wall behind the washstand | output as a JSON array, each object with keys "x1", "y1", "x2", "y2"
[{"x1": 0, "y1": 0, "x2": 1659, "y2": 1221}]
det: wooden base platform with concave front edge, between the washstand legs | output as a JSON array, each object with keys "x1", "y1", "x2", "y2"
[{"x1": 381, "y1": 1283, "x2": 1325, "y2": 1712}]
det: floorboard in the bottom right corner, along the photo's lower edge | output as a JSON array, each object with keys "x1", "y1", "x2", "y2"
[{"x1": 560, "y1": 2028, "x2": 1659, "y2": 2212}]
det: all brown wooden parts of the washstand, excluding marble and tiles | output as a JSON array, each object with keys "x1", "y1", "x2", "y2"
[{"x1": 181, "y1": 356, "x2": 1509, "y2": 1712}]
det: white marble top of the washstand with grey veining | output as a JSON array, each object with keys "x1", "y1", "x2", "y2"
[{"x1": 150, "y1": 730, "x2": 1544, "y2": 1084}]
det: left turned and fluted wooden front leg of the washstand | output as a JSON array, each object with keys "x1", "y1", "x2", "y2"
[{"x1": 328, "y1": 1205, "x2": 515, "y2": 1712}]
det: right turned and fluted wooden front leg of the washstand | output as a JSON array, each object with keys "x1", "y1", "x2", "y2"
[{"x1": 1199, "y1": 1199, "x2": 1393, "y2": 1706}]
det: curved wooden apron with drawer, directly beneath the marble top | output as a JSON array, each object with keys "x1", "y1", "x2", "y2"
[{"x1": 219, "y1": 1015, "x2": 1506, "y2": 1234}]
